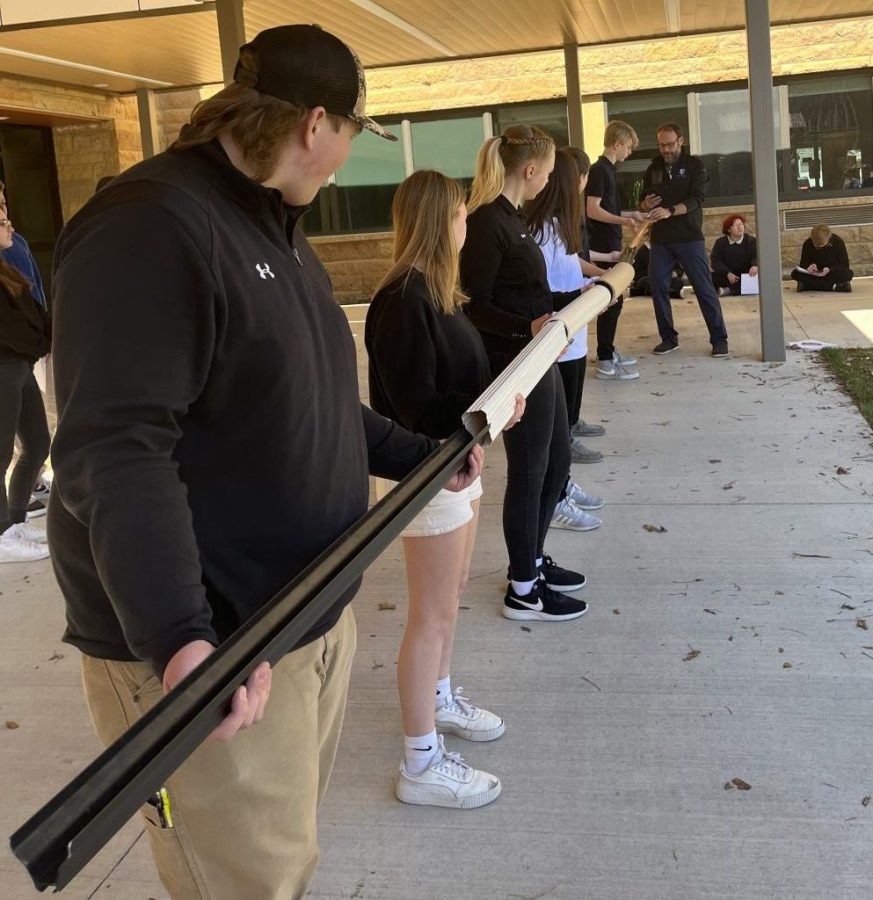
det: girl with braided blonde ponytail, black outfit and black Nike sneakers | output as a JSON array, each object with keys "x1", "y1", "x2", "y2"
[{"x1": 461, "y1": 125, "x2": 588, "y2": 621}]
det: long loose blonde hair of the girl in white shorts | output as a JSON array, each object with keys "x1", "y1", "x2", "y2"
[{"x1": 376, "y1": 169, "x2": 467, "y2": 316}]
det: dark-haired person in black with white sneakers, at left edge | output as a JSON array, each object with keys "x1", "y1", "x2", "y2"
[{"x1": 0, "y1": 213, "x2": 51, "y2": 562}]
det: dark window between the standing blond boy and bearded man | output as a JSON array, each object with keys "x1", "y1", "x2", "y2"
[{"x1": 606, "y1": 90, "x2": 688, "y2": 209}]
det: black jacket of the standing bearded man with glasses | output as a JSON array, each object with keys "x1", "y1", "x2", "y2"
[{"x1": 642, "y1": 150, "x2": 707, "y2": 244}]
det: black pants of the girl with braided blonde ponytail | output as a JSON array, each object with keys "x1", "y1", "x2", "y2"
[{"x1": 503, "y1": 363, "x2": 570, "y2": 581}]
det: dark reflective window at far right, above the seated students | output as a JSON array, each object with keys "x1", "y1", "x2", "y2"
[{"x1": 785, "y1": 75, "x2": 873, "y2": 196}]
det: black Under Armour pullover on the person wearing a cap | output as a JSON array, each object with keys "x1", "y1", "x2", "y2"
[{"x1": 49, "y1": 142, "x2": 436, "y2": 675}]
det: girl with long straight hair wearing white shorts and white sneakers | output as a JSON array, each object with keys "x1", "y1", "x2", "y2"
[{"x1": 364, "y1": 170, "x2": 524, "y2": 809}]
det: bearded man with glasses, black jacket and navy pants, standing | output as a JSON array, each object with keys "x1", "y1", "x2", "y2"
[{"x1": 640, "y1": 122, "x2": 728, "y2": 356}]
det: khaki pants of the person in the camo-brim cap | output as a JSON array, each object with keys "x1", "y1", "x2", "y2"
[{"x1": 82, "y1": 607, "x2": 356, "y2": 900}]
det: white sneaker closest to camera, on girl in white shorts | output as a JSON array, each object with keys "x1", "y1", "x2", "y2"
[{"x1": 394, "y1": 736, "x2": 502, "y2": 809}]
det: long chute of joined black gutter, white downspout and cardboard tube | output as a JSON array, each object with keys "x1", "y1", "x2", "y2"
[{"x1": 10, "y1": 264, "x2": 633, "y2": 891}]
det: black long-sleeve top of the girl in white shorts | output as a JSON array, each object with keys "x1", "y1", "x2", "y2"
[{"x1": 364, "y1": 269, "x2": 491, "y2": 438}]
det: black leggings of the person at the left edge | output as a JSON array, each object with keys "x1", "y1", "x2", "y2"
[{"x1": 0, "y1": 359, "x2": 49, "y2": 531}]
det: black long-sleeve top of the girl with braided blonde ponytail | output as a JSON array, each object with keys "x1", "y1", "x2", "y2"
[{"x1": 461, "y1": 194, "x2": 553, "y2": 376}]
